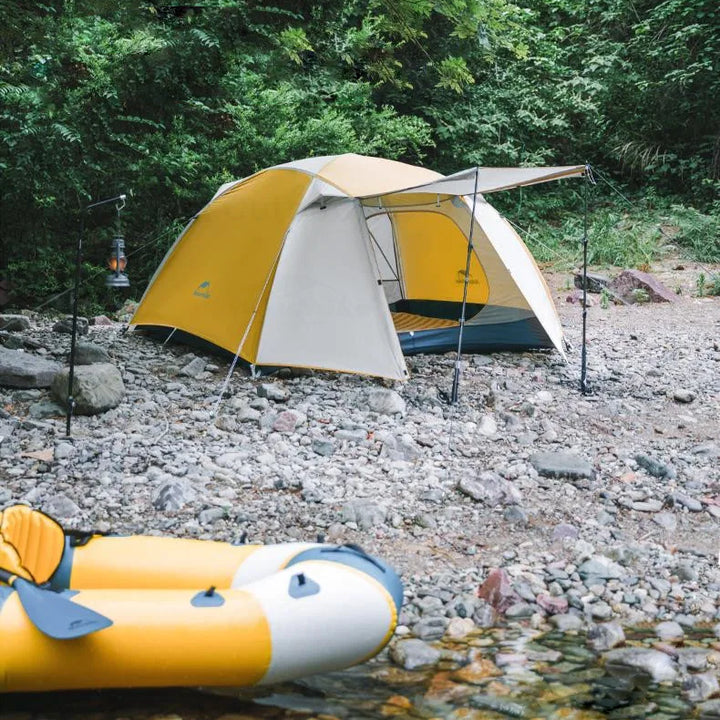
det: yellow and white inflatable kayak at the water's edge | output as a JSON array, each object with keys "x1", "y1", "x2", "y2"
[{"x1": 0, "y1": 506, "x2": 402, "y2": 692}]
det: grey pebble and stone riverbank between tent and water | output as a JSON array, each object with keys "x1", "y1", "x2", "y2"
[{"x1": 0, "y1": 268, "x2": 720, "y2": 717}]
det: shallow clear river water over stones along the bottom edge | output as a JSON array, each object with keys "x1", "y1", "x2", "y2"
[{"x1": 0, "y1": 627, "x2": 720, "y2": 720}]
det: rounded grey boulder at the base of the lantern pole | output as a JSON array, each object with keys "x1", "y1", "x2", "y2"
[{"x1": 52, "y1": 363, "x2": 125, "y2": 415}]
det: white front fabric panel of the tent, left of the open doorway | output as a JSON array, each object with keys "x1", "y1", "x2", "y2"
[{"x1": 257, "y1": 199, "x2": 407, "y2": 378}]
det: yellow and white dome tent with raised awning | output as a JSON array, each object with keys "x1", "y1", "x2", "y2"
[{"x1": 132, "y1": 154, "x2": 585, "y2": 379}]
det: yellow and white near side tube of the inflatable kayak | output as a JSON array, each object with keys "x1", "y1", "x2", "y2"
[{"x1": 0, "y1": 547, "x2": 402, "y2": 692}]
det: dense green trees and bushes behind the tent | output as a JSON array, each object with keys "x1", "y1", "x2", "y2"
[{"x1": 0, "y1": 0, "x2": 720, "y2": 304}]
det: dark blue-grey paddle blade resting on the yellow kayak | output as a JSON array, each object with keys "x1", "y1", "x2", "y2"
[{"x1": 11, "y1": 577, "x2": 112, "y2": 640}]
